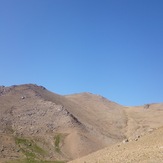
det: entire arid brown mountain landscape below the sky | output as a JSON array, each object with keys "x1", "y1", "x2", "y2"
[{"x1": 0, "y1": 84, "x2": 163, "y2": 163}]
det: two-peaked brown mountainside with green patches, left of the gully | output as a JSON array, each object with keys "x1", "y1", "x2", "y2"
[{"x1": 0, "y1": 84, "x2": 126, "y2": 160}]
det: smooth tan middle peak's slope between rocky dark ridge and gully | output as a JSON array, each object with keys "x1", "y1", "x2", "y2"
[{"x1": 66, "y1": 93, "x2": 127, "y2": 144}]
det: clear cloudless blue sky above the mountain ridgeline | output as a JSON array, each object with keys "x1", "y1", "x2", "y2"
[{"x1": 0, "y1": 0, "x2": 163, "y2": 105}]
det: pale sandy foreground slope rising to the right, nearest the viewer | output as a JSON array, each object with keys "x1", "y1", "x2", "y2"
[{"x1": 69, "y1": 128, "x2": 163, "y2": 163}]
